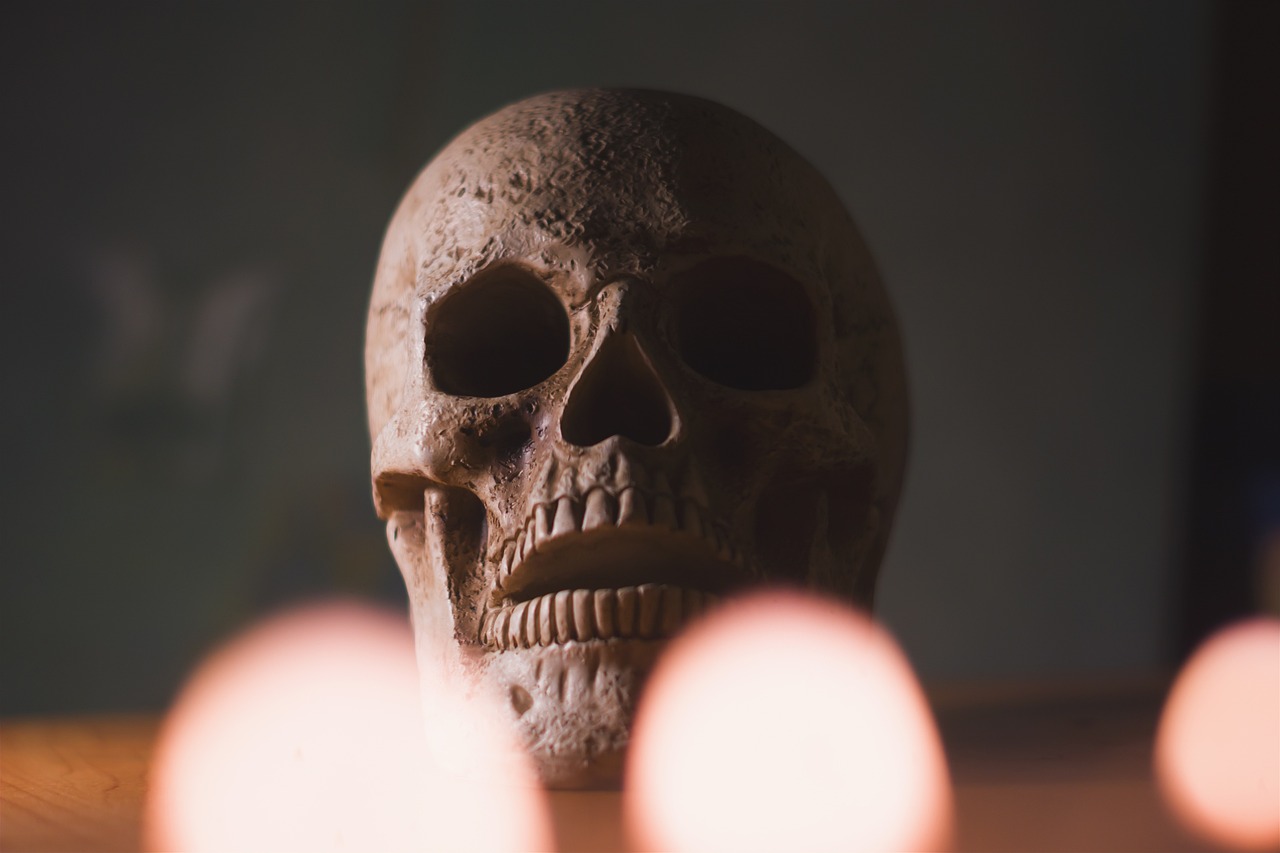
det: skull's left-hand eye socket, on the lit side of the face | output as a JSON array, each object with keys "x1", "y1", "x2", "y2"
[{"x1": 426, "y1": 266, "x2": 570, "y2": 397}]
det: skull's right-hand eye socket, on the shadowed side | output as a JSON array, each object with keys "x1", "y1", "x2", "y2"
[{"x1": 672, "y1": 257, "x2": 818, "y2": 391}]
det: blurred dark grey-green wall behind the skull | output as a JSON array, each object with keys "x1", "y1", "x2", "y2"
[{"x1": 0, "y1": 0, "x2": 1269, "y2": 713}]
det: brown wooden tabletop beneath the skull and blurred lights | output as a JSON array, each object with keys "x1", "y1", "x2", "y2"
[{"x1": 0, "y1": 680, "x2": 1211, "y2": 853}]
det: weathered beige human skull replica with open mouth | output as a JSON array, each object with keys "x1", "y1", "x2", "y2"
[{"x1": 366, "y1": 90, "x2": 906, "y2": 788}]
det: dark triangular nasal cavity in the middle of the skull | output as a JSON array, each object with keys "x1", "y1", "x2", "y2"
[{"x1": 561, "y1": 334, "x2": 671, "y2": 447}]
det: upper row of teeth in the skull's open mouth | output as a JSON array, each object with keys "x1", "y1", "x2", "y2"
[{"x1": 493, "y1": 485, "x2": 744, "y2": 587}]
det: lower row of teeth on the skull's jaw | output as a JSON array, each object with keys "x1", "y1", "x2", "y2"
[{"x1": 480, "y1": 584, "x2": 719, "y2": 649}]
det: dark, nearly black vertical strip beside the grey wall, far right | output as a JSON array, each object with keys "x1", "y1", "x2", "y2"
[{"x1": 1178, "y1": 3, "x2": 1280, "y2": 656}]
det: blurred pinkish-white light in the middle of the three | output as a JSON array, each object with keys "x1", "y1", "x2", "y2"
[{"x1": 626, "y1": 593, "x2": 951, "y2": 850}]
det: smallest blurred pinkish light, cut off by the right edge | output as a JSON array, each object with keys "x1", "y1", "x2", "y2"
[{"x1": 1156, "y1": 619, "x2": 1280, "y2": 849}]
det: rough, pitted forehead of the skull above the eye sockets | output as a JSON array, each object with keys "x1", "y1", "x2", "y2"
[{"x1": 393, "y1": 90, "x2": 851, "y2": 292}]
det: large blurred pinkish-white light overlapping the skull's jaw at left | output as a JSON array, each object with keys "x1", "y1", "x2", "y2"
[{"x1": 145, "y1": 603, "x2": 550, "y2": 850}]
